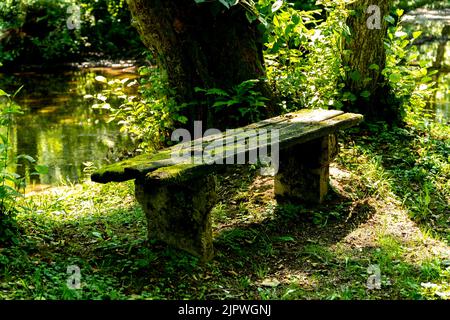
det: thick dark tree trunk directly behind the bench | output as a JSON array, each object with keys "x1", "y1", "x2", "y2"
[{"x1": 127, "y1": 0, "x2": 270, "y2": 125}]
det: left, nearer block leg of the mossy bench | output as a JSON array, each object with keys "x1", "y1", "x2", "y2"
[{"x1": 135, "y1": 175, "x2": 216, "y2": 261}]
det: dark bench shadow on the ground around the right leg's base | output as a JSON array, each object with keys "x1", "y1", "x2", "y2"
[{"x1": 215, "y1": 185, "x2": 375, "y2": 265}]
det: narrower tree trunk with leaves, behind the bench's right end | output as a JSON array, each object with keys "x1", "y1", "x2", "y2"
[{"x1": 343, "y1": 0, "x2": 401, "y2": 122}]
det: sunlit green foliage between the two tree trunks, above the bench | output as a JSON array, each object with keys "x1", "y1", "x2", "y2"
[{"x1": 258, "y1": 0, "x2": 349, "y2": 111}]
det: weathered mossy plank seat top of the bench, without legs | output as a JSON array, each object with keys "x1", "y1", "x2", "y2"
[{"x1": 91, "y1": 110, "x2": 363, "y2": 183}]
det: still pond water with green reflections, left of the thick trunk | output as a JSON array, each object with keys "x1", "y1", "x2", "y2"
[{"x1": 0, "y1": 64, "x2": 138, "y2": 190}]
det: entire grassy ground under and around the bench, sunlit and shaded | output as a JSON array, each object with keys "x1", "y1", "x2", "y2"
[{"x1": 0, "y1": 119, "x2": 450, "y2": 299}]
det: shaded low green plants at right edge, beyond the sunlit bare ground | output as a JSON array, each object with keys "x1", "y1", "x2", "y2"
[{"x1": 345, "y1": 123, "x2": 450, "y2": 241}]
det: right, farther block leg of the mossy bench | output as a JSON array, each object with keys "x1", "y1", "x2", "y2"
[{"x1": 275, "y1": 134, "x2": 338, "y2": 203}]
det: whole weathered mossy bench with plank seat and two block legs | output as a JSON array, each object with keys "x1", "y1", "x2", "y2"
[{"x1": 92, "y1": 109, "x2": 363, "y2": 260}]
